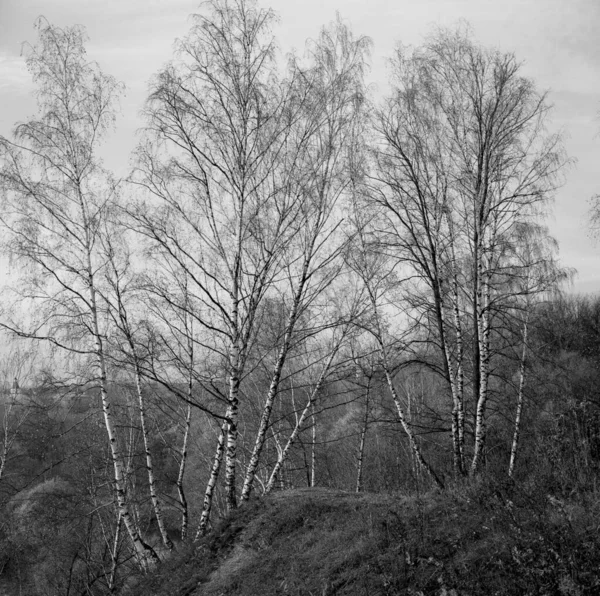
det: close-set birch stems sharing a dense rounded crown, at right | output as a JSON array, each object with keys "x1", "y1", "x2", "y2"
[{"x1": 373, "y1": 29, "x2": 565, "y2": 474}]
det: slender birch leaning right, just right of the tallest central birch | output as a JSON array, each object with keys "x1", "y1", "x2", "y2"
[{"x1": 241, "y1": 19, "x2": 370, "y2": 500}]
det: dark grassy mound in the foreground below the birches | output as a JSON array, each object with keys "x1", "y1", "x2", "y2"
[{"x1": 125, "y1": 486, "x2": 600, "y2": 596}]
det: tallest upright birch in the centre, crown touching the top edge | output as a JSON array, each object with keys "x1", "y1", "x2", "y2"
[{"x1": 131, "y1": 0, "x2": 312, "y2": 509}]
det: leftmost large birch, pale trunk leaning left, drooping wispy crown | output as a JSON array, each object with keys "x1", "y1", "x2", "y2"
[{"x1": 0, "y1": 19, "x2": 156, "y2": 566}]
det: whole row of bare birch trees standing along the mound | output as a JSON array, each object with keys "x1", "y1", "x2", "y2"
[{"x1": 0, "y1": 0, "x2": 565, "y2": 580}]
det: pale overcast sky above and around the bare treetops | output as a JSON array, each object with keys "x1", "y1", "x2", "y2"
[{"x1": 0, "y1": 0, "x2": 600, "y2": 292}]
